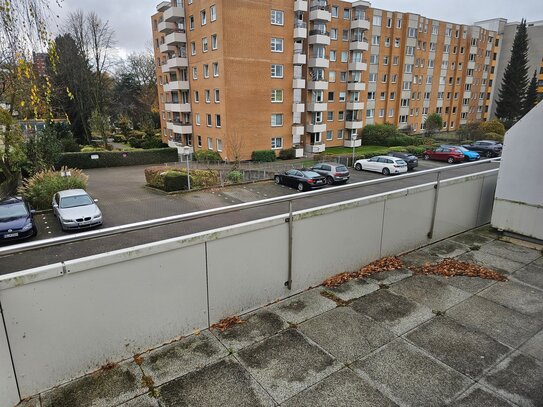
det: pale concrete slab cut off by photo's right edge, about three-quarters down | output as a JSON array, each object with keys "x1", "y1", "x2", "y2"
[{"x1": 477, "y1": 281, "x2": 543, "y2": 320}]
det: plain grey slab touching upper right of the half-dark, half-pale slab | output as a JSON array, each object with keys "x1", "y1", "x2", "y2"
[{"x1": 299, "y1": 307, "x2": 396, "y2": 364}]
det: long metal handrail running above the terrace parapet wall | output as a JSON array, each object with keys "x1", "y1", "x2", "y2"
[{"x1": 0, "y1": 158, "x2": 500, "y2": 256}]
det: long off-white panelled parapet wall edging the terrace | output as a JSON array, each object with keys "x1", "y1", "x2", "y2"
[{"x1": 0, "y1": 170, "x2": 497, "y2": 406}]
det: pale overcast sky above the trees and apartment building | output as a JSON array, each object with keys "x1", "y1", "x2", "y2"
[{"x1": 53, "y1": 0, "x2": 543, "y2": 55}]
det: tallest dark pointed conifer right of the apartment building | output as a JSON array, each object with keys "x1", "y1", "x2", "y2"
[{"x1": 496, "y1": 20, "x2": 528, "y2": 128}]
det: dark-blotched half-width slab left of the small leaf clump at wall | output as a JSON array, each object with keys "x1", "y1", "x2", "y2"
[{"x1": 141, "y1": 330, "x2": 228, "y2": 387}]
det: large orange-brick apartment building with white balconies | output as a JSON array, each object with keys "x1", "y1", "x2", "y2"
[{"x1": 152, "y1": 0, "x2": 500, "y2": 159}]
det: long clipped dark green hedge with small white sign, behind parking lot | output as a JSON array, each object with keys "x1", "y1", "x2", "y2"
[{"x1": 56, "y1": 148, "x2": 179, "y2": 169}]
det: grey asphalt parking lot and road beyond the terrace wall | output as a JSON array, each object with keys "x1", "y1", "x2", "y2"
[{"x1": 0, "y1": 161, "x2": 497, "y2": 274}]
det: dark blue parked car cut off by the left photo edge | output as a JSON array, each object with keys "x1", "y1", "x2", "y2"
[{"x1": 0, "y1": 196, "x2": 37, "y2": 243}]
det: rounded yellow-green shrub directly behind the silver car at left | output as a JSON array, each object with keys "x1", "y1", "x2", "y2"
[{"x1": 18, "y1": 168, "x2": 88, "y2": 209}]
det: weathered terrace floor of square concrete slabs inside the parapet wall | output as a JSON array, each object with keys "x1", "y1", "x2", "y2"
[{"x1": 21, "y1": 227, "x2": 543, "y2": 407}]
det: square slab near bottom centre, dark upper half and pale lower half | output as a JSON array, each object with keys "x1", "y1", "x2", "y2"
[{"x1": 237, "y1": 329, "x2": 342, "y2": 403}]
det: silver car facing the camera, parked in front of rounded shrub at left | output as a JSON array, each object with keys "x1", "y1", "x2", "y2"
[{"x1": 53, "y1": 189, "x2": 102, "y2": 230}]
